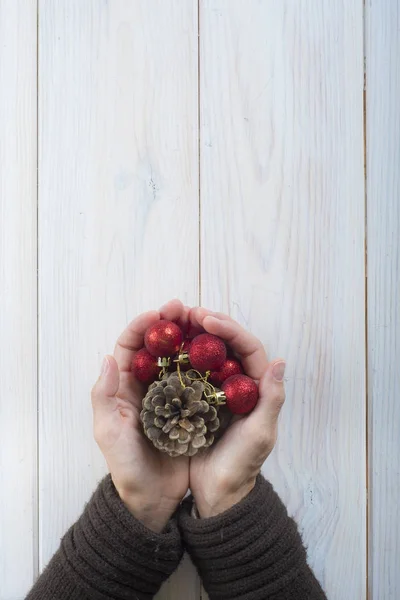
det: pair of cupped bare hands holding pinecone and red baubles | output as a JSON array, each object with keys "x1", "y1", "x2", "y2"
[{"x1": 92, "y1": 300, "x2": 285, "y2": 532}]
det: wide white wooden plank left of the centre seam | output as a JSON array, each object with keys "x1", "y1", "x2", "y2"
[{"x1": 39, "y1": 0, "x2": 199, "y2": 600}]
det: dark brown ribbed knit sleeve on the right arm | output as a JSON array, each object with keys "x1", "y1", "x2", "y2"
[{"x1": 180, "y1": 475, "x2": 326, "y2": 600}]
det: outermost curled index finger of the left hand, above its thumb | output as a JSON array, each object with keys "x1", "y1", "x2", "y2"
[{"x1": 114, "y1": 310, "x2": 160, "y2": 372}]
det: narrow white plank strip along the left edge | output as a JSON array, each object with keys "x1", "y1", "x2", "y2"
[{"x1": 0, "y1": 0, "x2": 37, "y2": 600}]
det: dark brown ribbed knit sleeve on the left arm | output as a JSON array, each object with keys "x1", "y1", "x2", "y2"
[{"x1": 26, "y1": 475, "x2": 182, "y2": 600}]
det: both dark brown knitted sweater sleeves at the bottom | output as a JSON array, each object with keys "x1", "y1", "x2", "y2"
[{"x1": 26, "y1": 476, "x2": 325, "y2": 600}]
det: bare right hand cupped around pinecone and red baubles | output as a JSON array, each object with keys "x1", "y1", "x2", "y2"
[{"x1": 190, "y1": 308, "x2": 285, "y2": 518}]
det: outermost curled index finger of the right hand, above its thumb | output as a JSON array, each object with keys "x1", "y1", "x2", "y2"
[{"x1": 202, "y1": 315, "x2": 268, "y2": 379}]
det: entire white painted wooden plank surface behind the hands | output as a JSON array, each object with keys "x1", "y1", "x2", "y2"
[{"x1": 0, "y1": 0, "x2": 400, "y2": 600}]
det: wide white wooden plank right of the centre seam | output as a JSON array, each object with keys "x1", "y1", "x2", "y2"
[{"x1": 200, "y1": 0, "x2": 366, "y2": 600}]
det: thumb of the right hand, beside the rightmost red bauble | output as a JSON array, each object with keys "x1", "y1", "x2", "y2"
[{"x1": 251, "y1": 358, "x2": 286, "y2": 428}]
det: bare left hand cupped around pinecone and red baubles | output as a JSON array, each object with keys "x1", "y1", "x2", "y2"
[{"x1": 92, "y1": 300, "x2": 189, "y2": 532}]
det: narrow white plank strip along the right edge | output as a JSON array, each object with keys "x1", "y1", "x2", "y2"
[{"x1": 366, "y1": 0, "x2": 400, "y2": 600}]
